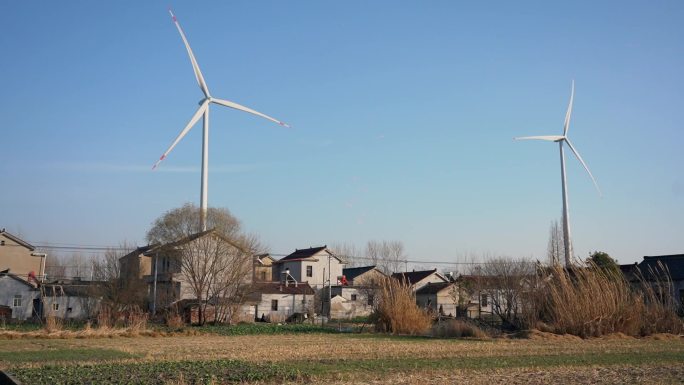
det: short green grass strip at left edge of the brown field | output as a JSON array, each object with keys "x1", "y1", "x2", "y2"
[{"x1": 0, "y1": 349, "x2": 136, "y2": 363}]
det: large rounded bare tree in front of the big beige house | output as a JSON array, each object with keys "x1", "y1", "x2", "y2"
[{"x1": 147, "y1": 204, "x2": 262, "y2": 324}]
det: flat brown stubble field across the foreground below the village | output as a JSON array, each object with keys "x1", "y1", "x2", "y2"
[{"x1": 0, "y1": 333, "x2": 684, "y2": 384}]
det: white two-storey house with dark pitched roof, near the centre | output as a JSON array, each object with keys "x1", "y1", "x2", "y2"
[{"x1": 272, "y1": 246, "x2": 345, "y2": 289}]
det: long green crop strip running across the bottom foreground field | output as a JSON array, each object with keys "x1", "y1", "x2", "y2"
[{"x1": 10, "y1": 351, "x2": 684, "y2": 385}]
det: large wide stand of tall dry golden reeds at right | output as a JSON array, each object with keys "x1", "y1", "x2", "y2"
[{"x1": 529, "y1": 265, "x2": 682, "y2": 338}]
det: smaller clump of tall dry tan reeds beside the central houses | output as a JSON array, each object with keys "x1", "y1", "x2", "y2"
[{"x1": 374, "y1": 278, "x2": 432, "y2": 335}]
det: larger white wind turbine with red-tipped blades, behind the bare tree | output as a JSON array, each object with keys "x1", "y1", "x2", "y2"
[{"x1": 152, "y1": 9, "x2": 290, "y2": 231}]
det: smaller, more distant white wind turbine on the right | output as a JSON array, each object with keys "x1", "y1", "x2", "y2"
[{"x1": 515, "y1": 80, "x2": 601, "y2": 266}]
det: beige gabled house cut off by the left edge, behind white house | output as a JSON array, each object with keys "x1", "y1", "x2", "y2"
[{"x1": 0, "y1": 229, "x2": 47, "y2": 280}]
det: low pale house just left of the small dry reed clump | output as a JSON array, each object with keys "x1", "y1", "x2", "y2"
[{"x1": 323, "y1": 266, "x2": 387, "y2": 319}]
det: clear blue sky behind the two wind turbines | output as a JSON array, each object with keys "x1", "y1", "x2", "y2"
[{"x1": 0, "y1": 0, "x2": 684, "y2": 263}]
